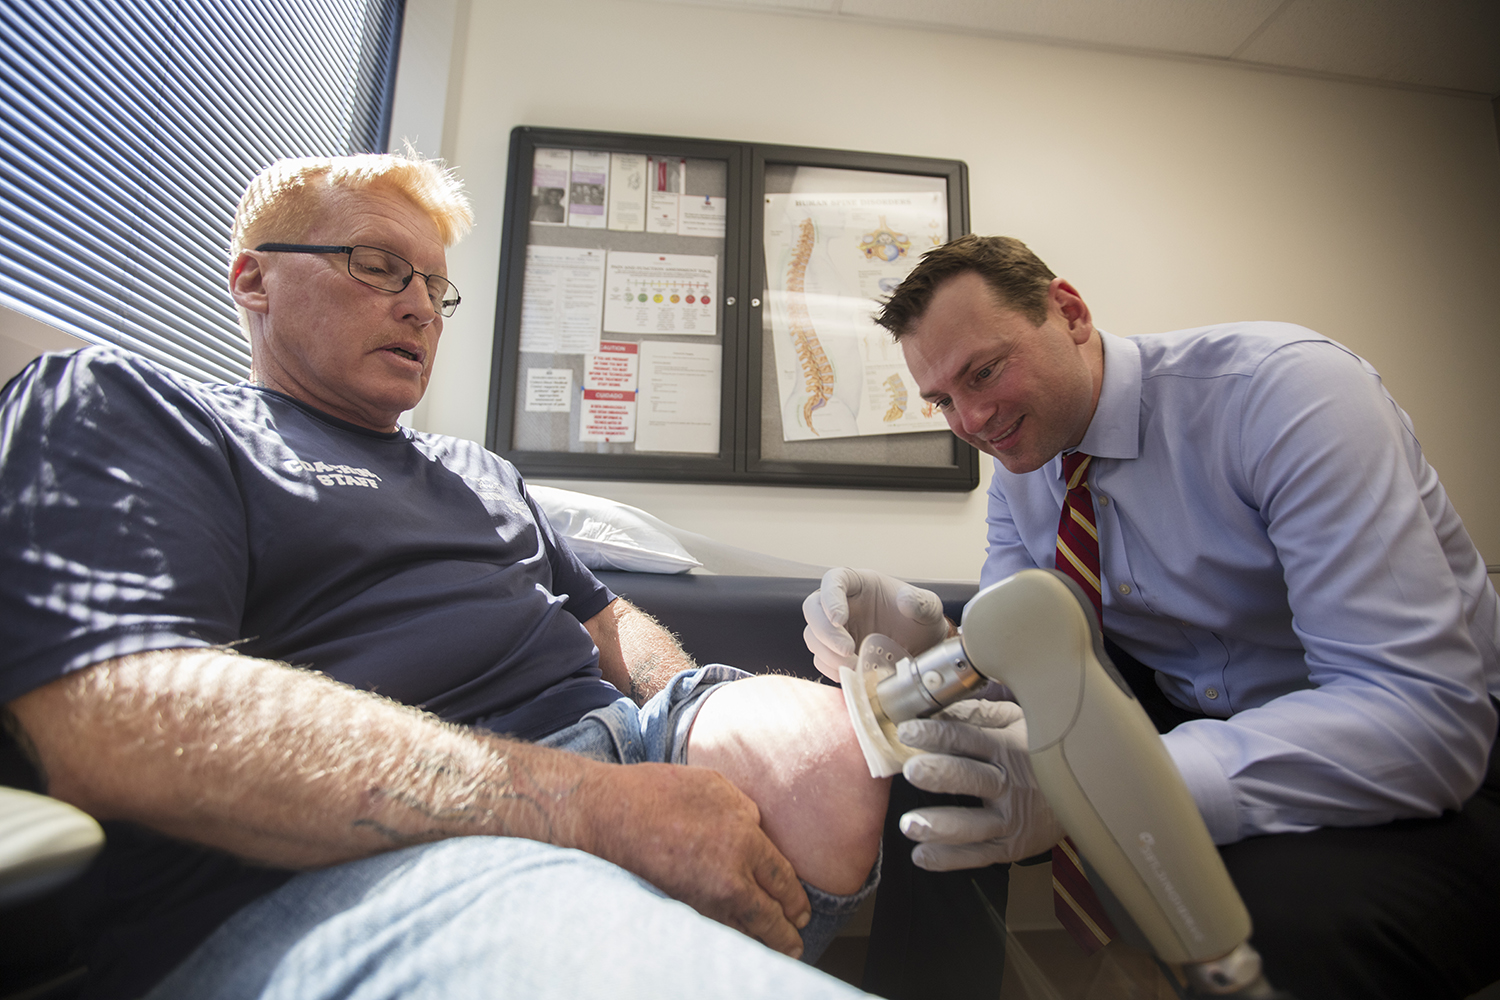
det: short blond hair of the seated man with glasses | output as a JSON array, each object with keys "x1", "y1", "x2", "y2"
[{"x1": 230, "y1": 148, "x2": 474, "y2": 261}]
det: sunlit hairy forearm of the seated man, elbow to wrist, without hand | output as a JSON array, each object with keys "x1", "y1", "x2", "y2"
[{"x1": 11, "y1": 649, "x2": 603, "y2": 868}]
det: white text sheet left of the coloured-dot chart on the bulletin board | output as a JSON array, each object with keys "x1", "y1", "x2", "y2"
[{"x1": 521, "y1": 243, "x2": 605, "y2": 354}]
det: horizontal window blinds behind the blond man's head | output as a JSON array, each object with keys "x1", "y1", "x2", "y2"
[{"x1": 0, "y1": 0, "x2": 405, "y2": 381}]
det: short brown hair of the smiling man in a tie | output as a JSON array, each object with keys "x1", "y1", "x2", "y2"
[{"x1": 875, "y1": 235, "x2": 1056, "y2": 340}]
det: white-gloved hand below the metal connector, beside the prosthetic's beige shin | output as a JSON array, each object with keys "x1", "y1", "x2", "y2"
[{"x1": 896, "y1": 700, "x2": 1064, "y2": 871}]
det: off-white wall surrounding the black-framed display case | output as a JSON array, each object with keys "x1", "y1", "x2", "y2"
[{"x1": 417, "y1": 0, "x2": 1500, "y2": 579}]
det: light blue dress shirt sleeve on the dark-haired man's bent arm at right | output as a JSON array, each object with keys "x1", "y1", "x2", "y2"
[{"x1": 1164, "y1": 342, "x2": 1496, "y2": 843}]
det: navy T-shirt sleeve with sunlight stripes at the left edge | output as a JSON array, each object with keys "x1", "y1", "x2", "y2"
[{"x1": 0, "y1": 348, "x2": 248, "y2": 702}]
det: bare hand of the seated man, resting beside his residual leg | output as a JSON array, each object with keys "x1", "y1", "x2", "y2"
[{"x1": 572, "y1": 763, "x2": 812, "y2": 958}]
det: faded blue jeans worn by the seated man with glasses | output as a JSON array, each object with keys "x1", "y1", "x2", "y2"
[{"x1": 149, "y1": 664, "x2": 879, "y2": 1000}]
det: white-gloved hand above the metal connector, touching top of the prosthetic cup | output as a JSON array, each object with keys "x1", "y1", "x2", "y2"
[{"x1": 803, "y1": 567, "x2": 948, "y2": 681}]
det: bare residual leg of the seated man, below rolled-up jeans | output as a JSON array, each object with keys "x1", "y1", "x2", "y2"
[{"x1": 687, "y1": 675, "x2": 890, "y2": 895}]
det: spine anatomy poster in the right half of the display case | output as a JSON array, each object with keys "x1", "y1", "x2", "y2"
[{"x1": 765, "y1": 192, "x2": 948, "y2": 441}]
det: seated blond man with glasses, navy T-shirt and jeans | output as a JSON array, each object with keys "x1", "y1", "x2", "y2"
[{"x1": 0, "y1": 156, "x2": 887, "y2": 997}]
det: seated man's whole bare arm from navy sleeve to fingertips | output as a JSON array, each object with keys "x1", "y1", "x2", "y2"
[{"x1": 9, "y1": 649, "x2": 812, "y2": 955}]
